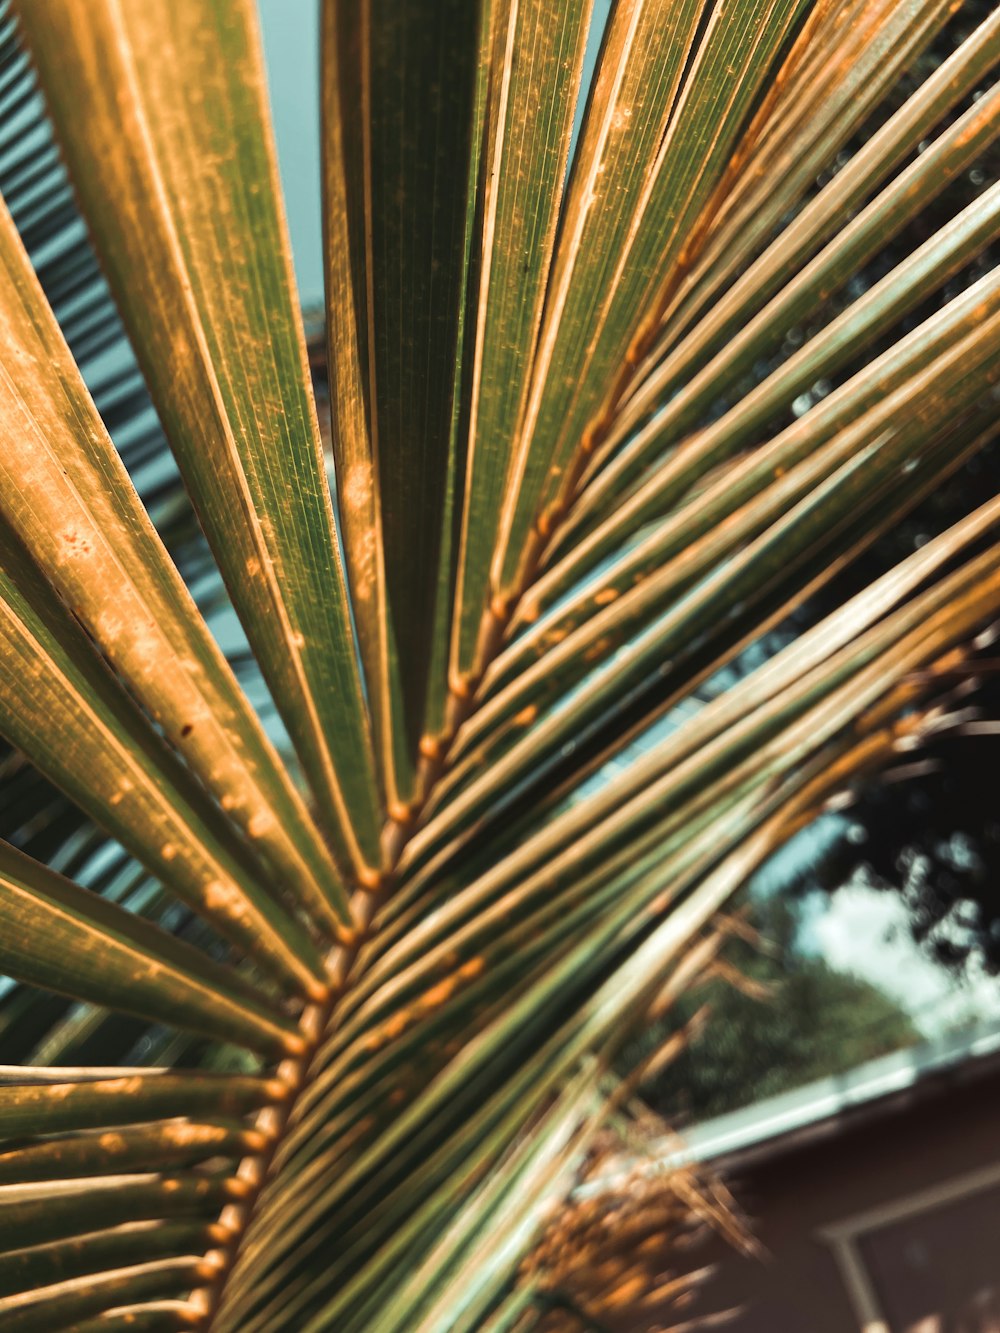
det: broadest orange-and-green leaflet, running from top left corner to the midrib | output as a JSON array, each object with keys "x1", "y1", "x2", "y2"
[{"x1": 20, "y1": 0, "x2": 381, "y2": 877}]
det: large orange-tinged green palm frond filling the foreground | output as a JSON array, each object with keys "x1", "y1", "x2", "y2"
[{"x1": 0, "y1": 0, "x2": 1000, "y2": 1333}]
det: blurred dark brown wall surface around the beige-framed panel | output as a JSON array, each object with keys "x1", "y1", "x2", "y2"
[{"x1": 632, "y1": 1074, "x2": 1000, "y2": 1333}]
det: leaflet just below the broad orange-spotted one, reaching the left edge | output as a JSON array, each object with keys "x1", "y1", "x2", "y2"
[{"x1": 0, "y1": 525, "x2": 325, "y2": 997}]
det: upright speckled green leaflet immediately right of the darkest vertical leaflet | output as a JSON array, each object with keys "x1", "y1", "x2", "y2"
[{"x1": 449, "y1": 0, "x2": 592, "y2": 682}]
